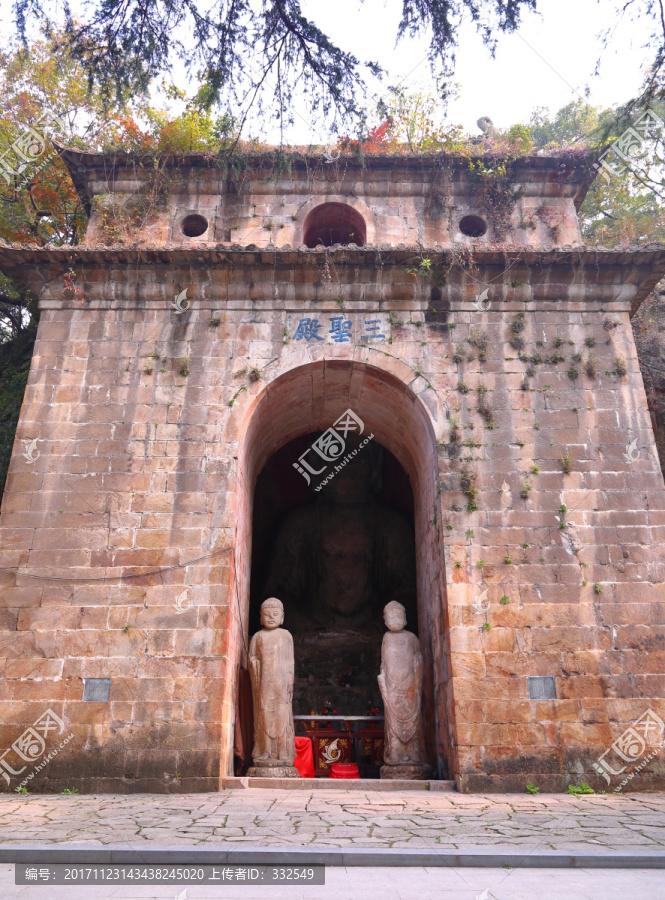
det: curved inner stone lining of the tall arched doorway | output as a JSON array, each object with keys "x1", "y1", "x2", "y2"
[{"x1": 225, "y1": 359, "x2": 453, "y2": 777}]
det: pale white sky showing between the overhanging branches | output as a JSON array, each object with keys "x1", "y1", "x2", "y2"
[{"x1": 6, "y1": 0, "x2": 654, "y2": 144}]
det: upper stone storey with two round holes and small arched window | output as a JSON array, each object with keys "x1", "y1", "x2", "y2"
[{"x1": 64, "y1": 150, "x2": 593, "y2": 247}]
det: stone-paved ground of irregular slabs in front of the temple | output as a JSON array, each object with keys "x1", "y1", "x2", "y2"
[{"x1": 0, "y1": 788, "x2": 665, "y2": 852}]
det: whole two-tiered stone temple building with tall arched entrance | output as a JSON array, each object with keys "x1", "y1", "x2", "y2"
[{"x1": 0, "y1": 145, "x2": 665, "y2": 792}]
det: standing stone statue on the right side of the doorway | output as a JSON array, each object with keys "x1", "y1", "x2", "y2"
[{"x1": 378, "y1": 601, "x2": 432, "y2": 780}]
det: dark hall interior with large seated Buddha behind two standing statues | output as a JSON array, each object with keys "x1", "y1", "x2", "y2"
[{"x1": 249, "y1": 432, "x2": 418, "y2": 715}]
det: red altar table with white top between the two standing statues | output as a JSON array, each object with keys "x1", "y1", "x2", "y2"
[{"x1": 293, "y1": 715, "x2": 383, "y2": 778}]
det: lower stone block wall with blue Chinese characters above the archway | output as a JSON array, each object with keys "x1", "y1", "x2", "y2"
[{"x1": 0, "y1": 248, "x2": 665, "y2": 791}]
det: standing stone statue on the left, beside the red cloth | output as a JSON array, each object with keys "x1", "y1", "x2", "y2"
[{"x1": 247, "y1": 597, "x2": 300, "y2": 778}]
